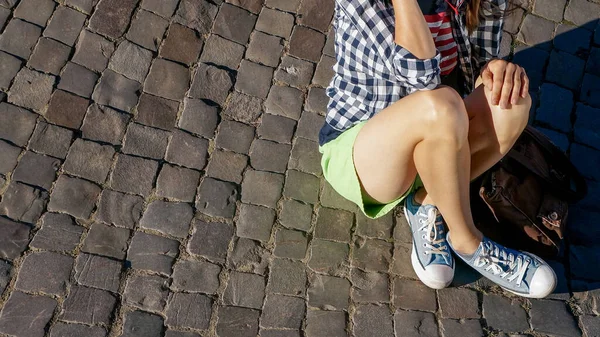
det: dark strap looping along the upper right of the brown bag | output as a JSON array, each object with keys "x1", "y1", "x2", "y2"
[{"x1": 507, "y1": 125, "x2": 587, "y2": 202}]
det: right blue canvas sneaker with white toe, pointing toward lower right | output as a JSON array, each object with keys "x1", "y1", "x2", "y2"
[{"x1": 448, "y1": 237, "x2": 557, "y2": 298}]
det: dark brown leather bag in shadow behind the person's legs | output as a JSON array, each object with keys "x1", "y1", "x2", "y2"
[{"x1": 473, "y1": 126, "x2": 587, "y2": 257}]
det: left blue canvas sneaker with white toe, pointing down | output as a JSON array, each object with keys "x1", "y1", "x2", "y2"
[{"x1": 404, "y1": 193, "x2": 454, "y2": 289}]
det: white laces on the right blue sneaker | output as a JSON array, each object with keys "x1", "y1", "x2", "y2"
[{"x1": 474, "y1": 241, "x2": 531, "y2": 287}]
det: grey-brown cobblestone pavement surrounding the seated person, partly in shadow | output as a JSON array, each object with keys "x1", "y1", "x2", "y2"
[{"x1": 0, "y1": 0, "x2": 600, "y2": 337}]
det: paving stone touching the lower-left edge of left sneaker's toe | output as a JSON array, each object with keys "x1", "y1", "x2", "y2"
[{"x1": 393, "y1": 278, "x2": 437, "y2": 312}]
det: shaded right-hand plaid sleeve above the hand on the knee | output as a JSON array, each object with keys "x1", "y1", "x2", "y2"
[{"x1": 470, "y1": 0, "x2": 507, "y2": 76}]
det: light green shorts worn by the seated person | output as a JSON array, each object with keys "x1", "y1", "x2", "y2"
[{"x1": 319, "y1": 121, "x2": 423, "y2": 219}]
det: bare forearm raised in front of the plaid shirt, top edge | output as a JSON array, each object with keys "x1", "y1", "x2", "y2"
[{"x1": 392, "y1": 0, "x2": 436, "y2": 59}]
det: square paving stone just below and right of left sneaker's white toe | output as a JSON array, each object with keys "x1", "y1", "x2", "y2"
[{"x1": 438, "y1": 288, "x2": 481, "y2": 319}]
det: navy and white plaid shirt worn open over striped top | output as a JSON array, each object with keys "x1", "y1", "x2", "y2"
[{"x1": 319, "y1": 0, "x2": 507, "y2": 145}]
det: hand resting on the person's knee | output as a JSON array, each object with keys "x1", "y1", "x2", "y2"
[{"x1": 481, "y1": 59, "x2": 529, "y2": 109}]
